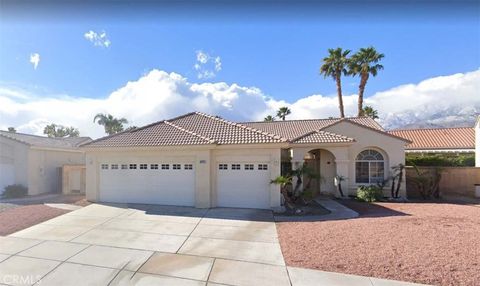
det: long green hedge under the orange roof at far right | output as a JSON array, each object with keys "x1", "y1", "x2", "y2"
[{"x1": 406, "y1": 154, "x2": 475, "y2": 167}]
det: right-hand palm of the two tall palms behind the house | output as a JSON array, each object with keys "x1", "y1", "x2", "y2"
[{"x1": 349, "y1": 47, "x2": 385, "y2": 116}]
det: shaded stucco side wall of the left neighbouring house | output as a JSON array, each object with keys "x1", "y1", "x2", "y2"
[{"x1": 28, "y1": 148, "x2": 85, "y2": 195}]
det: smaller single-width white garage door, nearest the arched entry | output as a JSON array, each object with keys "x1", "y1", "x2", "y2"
[{"x1": 217, "y1": 162, "x2": 270, "y2": 209}]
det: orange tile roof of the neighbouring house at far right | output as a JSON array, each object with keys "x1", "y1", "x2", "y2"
[{"x1": 388, "y1": 127, "x2": 475, "y2": 150}]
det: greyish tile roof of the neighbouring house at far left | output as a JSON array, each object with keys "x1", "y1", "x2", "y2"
[{"x1": 0, "y1": 130, "x2": 92, "y2": 149}]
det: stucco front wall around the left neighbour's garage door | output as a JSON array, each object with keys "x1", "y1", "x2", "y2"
[{"x1": 0, "y1": 136, "x2": 29, "y2": 189}]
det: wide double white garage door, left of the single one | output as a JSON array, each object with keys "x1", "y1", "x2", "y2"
[{"x1": 100, "y1": 160, "x2": 195, "y2": 206}]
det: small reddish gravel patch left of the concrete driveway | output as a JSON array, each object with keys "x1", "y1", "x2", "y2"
[{"x1": 0, "y1": 205, "x2": 69, "y2": 236}]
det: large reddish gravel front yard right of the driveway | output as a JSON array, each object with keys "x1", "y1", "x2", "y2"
[{"x1": 277, "y1": 201, "x2": 480, "y2": 285}]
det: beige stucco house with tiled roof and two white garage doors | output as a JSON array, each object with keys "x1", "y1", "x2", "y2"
[{"x1": 82, "y1": 112, "x2": 409, "y2": 209}]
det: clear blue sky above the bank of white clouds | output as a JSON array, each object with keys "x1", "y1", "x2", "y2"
[{"x1": 0, "y1": 1, "x2": 480, "y2": 137}]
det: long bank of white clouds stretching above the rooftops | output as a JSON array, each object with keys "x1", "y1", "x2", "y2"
[{"x1": 0, "y1": 70, "x2": 480, "y2": 137}]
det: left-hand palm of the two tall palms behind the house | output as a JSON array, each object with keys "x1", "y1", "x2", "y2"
[{"x1": 320, "y1": 48, "x2": 350, "y2": 118}]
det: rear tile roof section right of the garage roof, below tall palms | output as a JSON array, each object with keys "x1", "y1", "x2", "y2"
[{"x1": 242, "y1": 117, "x2": 384, "y2": 140}]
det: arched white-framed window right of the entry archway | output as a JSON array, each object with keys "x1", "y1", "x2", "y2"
[{"x1": 355, "y1": 150, "x2": 385, "y2": 184}]
